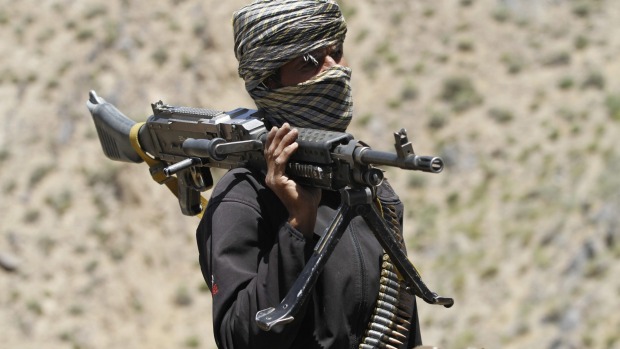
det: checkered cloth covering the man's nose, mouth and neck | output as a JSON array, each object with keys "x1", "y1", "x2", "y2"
[{"x1": 250, "y1": 65, "x2": 353, "y2": 132}]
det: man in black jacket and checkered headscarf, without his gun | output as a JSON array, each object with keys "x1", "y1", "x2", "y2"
[{"x1": 197, "y1": 0, "x2": 421, "y2": 349}]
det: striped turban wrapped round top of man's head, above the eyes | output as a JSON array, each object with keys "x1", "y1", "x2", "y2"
[{"x1": 233, "y1": 0, "x2": 347, "y2": 92}]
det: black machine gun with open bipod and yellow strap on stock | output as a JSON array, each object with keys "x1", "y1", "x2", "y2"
[{"x1": 87, "y1": 91, "x2": 454, "y2": 330}]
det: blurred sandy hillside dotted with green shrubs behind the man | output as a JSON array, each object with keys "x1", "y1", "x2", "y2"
[{"x1": 0, "y1": 0, "x2": 620, "y2": 349}]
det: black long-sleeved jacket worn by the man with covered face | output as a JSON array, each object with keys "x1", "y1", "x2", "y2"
[{"x1": 196, "y1": 168, "x2": 421, "y2": 349}]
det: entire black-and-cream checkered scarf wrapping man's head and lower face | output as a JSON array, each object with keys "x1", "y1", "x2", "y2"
[{"x1": 233, "y1": 0, "x2": 352, "y2": 131}]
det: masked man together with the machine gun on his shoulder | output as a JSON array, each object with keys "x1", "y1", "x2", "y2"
[{"x1": 87, "y1": 0, "x2": 454, "y2": 349}]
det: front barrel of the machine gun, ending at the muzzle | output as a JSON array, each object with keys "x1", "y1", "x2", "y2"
[{"x1": 359, "y1": 148, "x2": 443, "y2": 173}]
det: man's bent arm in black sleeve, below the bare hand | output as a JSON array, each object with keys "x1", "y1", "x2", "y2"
[{"x1": 197, "y1": 170, "x2": 308, "y2": 348}]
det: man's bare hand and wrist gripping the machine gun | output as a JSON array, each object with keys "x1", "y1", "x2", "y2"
[{"x1": 265, "y1": 123, "x2": 321, "y2": 238}]
